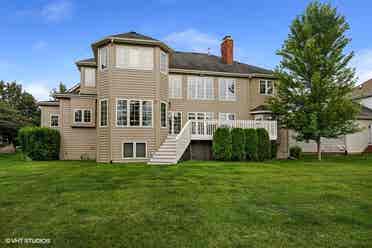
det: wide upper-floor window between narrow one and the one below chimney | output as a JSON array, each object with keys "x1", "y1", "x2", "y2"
[{"x1": 187, "y1": 77, "x2": 214, "y2": 100}]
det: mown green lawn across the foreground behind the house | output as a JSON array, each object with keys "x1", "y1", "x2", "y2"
[{"x1": 0, "y1": 155, "x2": 372, "y2": 248}]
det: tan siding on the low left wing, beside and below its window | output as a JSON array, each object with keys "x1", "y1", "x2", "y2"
[{"x1": 60, "y1": 99, "x2": 96, "y2": 160}]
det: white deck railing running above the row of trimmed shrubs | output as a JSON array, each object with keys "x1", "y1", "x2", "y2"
[{"x1": 192, "y1": 120, "x2": 277, "y2": 140}]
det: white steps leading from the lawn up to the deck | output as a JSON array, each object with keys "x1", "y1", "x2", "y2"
[{"x1": 147, "y1": 135, "x2": 177, "y2": 165}]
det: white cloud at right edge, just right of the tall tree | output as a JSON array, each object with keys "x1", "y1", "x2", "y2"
[{"x1": 351, "y1": 49, "x2": 372, "y2": 84}]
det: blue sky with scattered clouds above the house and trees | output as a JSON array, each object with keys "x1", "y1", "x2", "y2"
[{"x1": 0, "y1": 0, "x2": 372, "y2": 100}]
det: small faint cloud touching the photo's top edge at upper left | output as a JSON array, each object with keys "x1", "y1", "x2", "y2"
[{"x1": 41, "y1": 0, "x2": 72, "y2": 22}]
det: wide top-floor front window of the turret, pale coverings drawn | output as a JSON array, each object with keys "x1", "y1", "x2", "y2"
[{"x1": 116, "y1": 45, "x2": 154, "y2": 70}]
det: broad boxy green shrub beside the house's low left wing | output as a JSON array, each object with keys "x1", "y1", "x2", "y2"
[{"x1": 18, "y1": 127, "x2": 61, "y2": 160}]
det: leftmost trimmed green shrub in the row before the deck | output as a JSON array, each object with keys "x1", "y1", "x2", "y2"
[{"x1": 212, "y1": 127, "x2": 232, "y2": 161}]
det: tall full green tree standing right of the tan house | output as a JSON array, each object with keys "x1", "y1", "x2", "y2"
[{"x1": 270, "y1": 1, "x2": 359, "y2": 160}]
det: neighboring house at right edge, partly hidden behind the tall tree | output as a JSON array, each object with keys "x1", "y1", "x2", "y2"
[{"x1": 289, "y1": 79, "x2": 372, "y2": 153}]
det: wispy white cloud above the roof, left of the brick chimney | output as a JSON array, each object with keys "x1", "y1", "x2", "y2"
[{"x1": 164, "y1": 29, "x2": 220, "y2": 54}]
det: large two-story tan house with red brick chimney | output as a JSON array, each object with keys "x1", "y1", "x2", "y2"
[{"x1": 40, "y1": 32, "x2": 287, "y2": 163}]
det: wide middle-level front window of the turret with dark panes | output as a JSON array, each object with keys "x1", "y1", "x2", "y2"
[{"x1": 116, "y1": 99, "x2": 153, "y2": 127}]
